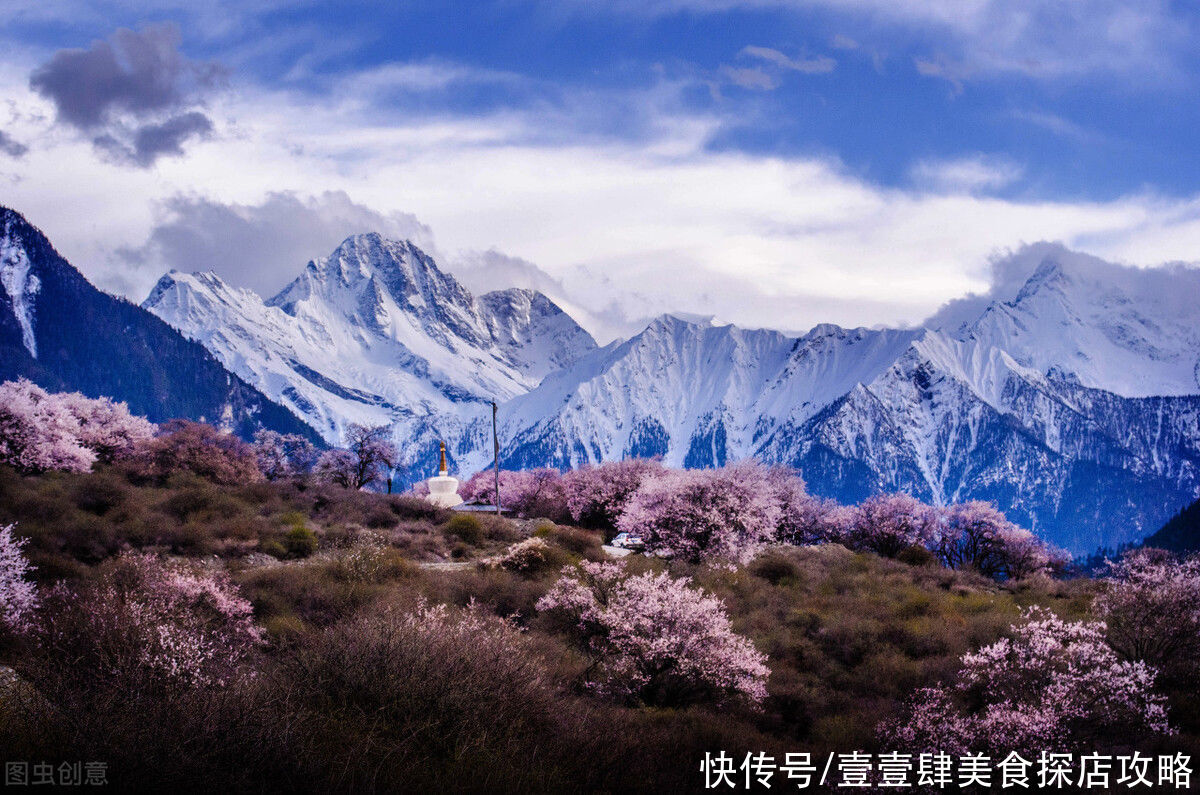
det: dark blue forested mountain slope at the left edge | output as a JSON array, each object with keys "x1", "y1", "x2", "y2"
[{"x1": 0, "y1": 208, "x2": 317, "y2": 440}]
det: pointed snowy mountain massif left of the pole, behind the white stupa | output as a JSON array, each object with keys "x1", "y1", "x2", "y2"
[{"x1": 143, "y1": 234, "x2": 596, "y2": 476}]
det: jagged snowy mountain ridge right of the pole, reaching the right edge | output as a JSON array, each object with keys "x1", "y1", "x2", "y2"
[{"x1": 464, "y1": 247, "x2": 1200, "y2": 551}]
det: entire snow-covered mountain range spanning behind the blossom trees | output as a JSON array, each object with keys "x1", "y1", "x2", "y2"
[{"x1": 0, "y1": 205, "x2": 1200, "y2": 552}]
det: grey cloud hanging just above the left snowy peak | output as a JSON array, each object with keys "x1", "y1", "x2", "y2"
[{"x1": 114, "y1": 191, "x2": 432, "y2": 298}]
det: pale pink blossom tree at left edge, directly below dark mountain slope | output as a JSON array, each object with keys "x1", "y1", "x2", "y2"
[{"x1": 0, "y1": 378, "x2": 96, "y2": 474}]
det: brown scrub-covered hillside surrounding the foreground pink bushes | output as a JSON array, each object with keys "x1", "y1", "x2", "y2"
[{"x1": 0, "y1": 467, "x2": 1195, "y2": 791}]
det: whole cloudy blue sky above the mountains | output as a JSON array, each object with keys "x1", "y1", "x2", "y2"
[{"x1": 0, "y1": 0, "x2": 1200, "y2": 340}]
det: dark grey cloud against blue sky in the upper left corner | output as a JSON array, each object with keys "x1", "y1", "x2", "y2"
[{"x1": 29, "y1": 24, "x2": 224, "y2": 167}]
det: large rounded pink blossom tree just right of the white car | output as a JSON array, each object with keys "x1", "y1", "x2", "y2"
[{"x1": 617, "y1": 461, "x2": 781, "y2": 563}]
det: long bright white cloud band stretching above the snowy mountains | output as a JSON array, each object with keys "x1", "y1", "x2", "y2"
[{"x1": 0, "y1": 58, "x2": 1200, "y2": 345}]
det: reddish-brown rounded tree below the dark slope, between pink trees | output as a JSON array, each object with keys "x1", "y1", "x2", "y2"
[{"x1": 131, "y1": 419, "x2": 263, "y2": 485}]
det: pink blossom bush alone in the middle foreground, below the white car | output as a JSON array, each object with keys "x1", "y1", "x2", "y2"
[{"x1": 538, "y1": 562, "x2": 770, "y2": 706}]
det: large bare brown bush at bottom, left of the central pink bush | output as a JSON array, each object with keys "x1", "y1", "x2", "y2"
[{"x1": 287, "y1": 604, "x2": 556, "y2": 791}]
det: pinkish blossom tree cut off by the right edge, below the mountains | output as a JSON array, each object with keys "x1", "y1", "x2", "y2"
[{"x1": 1096, "y1": 549, "x2": 1200, "y2": 676}]
